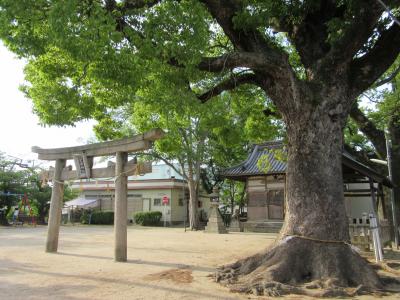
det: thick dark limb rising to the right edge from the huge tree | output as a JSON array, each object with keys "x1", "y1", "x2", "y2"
[{"x1": 350, "y1": 24, "x2": 400, "y2": 99}]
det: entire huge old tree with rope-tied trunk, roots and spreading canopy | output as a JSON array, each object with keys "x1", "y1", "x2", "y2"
[{"x1": 0, "y1": 0, "x2": 400, "y2": 295}]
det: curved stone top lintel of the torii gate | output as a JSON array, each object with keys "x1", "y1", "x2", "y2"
[{"x1": 32, "y1": 128, "x2": 164, "y2": 160}]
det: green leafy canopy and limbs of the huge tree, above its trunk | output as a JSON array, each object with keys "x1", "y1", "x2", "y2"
[{"x1": 0, "y1": 0, "x2": 399, "y2": 125}]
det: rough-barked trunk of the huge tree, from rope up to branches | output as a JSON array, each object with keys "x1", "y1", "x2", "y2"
[{"x1": 282, "y1": 108, "x2": 349, "y2": 242}]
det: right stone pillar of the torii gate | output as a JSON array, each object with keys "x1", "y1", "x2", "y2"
[{"x1": 114, "y1": 152, "x2": 128, "y2": 262}]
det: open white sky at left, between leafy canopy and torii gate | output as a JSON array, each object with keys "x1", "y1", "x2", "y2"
[{"x1": 0, "y1": 42, "x2": 95, "y2": 163}]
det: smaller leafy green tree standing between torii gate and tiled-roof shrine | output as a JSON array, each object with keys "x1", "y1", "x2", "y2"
[{"x1": 97, "y1": 88, "x2": 278, "y2": 229}]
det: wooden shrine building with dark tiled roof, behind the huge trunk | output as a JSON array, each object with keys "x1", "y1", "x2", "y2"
[{"x1": 221, "y1": 141, "x2": 390, "y2": 232}]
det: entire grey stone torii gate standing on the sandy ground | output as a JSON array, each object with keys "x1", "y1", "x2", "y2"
[{"x1": 32, "y1": 129, "x2": 164, "y2": 262}]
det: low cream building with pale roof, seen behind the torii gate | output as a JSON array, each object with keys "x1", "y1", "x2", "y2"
[{"x1": 72, "y1": 164, "x2": 188, "y2": 223}]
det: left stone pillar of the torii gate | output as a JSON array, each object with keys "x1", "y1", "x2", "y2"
[{"x1": 46, "y1": 159, "x2": 66, "y2": 252}]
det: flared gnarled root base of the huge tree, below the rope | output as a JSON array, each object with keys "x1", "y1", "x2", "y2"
[{"x1": 215, "y1": 238, "x2": 396, "y2": 297}]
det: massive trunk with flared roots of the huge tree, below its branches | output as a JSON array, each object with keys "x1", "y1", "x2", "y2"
[{"x1": 217, "y1": 102, "x2": 381, "y2": 296}]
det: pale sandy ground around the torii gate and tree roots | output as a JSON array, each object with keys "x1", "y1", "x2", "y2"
[{"x1": 0, "y1": 226, "x2": 400, "y2": 300}]
